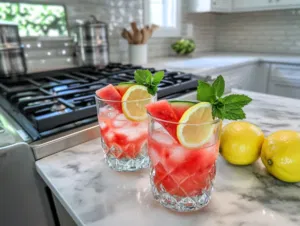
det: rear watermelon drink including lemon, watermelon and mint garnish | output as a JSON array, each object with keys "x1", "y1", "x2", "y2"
[{"x1": 96, "y1": 70, "x2": 163, "y2": 171}]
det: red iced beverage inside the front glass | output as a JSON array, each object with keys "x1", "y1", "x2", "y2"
[{"x1": 148, "y1": 129, "x2": 219, "y2": 197}]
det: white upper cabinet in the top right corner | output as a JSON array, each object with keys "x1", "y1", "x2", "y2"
[{"x1": 232, "y1": 0, "x2": 300, "y2": 12}]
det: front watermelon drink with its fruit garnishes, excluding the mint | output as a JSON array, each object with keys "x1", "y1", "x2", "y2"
[{"x1": 147, "y1": 100, "x2": 221, "y2": 212}]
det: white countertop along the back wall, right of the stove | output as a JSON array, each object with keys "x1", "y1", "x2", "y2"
[{"x1": 143, "y1": 52, "x2": 300, "y2": 76}]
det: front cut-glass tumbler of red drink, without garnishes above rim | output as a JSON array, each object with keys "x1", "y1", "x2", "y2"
[{"x1": 148, "y1": 115, "x2": 221, "y2": 212}]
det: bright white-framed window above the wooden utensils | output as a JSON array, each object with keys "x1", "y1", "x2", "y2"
[{"x1": 144, "y1": 0, "x2": 181, "y2": 37}]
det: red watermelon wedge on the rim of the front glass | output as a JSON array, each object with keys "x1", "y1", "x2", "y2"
[{"x1": 146, "y1": 100, "x2": 179, "y2": 141}]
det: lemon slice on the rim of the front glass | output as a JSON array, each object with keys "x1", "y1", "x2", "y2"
[{"x1": 177, "y1": 102, "x2": 214, "y2": 148}]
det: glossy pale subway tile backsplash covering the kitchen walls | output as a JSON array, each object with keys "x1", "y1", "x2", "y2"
[{"x1": 4, "y1": 0, "x2": 300, "y2": 70}]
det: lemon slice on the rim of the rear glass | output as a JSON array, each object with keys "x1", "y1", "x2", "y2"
[{"x1": 122, "y1": 85, "x2": 152, "y2": 121}]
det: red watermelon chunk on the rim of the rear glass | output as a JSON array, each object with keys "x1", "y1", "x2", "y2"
[{"x1": 96, "y1": 84, "x2": 122, "y2": 112}]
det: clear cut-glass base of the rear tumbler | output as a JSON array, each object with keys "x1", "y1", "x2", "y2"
[{"x1": 101, "y1": 139, "x2": 150, "y2": 172}]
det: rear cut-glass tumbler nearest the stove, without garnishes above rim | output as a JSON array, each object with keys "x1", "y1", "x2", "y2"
[{"x1": 95, "y1": 96, "x2": 155, "y2": 171}]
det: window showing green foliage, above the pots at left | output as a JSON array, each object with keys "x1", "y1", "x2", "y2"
[{"x1": 0, "y1": 2, "x2": 68, "y2": 36}]
